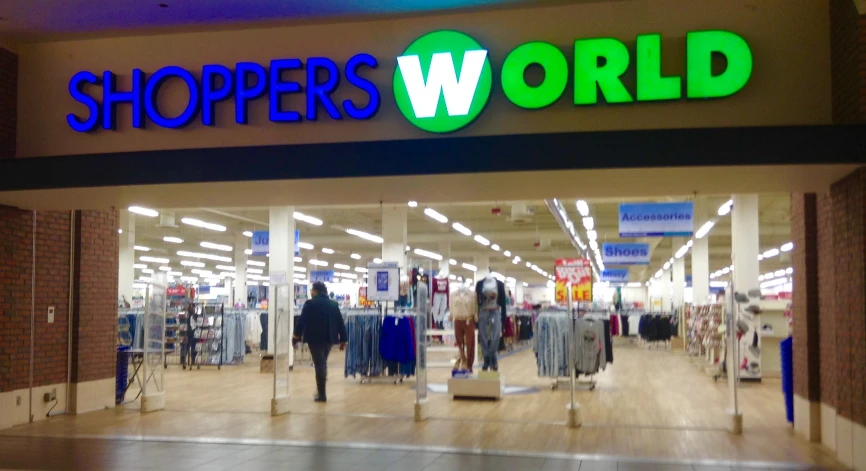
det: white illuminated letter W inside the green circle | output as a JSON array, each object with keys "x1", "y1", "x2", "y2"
[{"x1": 397, "y1": 50, "x2": 487, "y2": 118}]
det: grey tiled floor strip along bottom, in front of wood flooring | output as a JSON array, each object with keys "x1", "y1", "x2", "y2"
[{"x1": 0, "y1": 436, "x2": 828, "y2": 471}]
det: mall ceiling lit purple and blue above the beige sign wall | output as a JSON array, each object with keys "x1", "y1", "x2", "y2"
[{"x1": 0, "y1": 0, "x2": 572, "y2": 40}]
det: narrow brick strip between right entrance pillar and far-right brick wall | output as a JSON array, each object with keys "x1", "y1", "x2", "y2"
[{"x1": 817, "y1": 191, "x2": 839, "y2": 407}]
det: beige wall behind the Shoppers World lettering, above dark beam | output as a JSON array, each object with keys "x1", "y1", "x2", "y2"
[{"x1": 17, "y1": 0, "x2": 831, "y2": 157}]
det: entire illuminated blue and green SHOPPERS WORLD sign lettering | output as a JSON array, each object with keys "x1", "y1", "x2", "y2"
[{"x1": 66, "y1": 30, "x2": 752, "y2": 133}]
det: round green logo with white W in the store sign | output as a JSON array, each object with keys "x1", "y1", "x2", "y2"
[{"x1": 394, "y1": 31, "x2": 493, "y2": 133}]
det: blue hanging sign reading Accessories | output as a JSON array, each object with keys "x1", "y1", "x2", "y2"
[{"x1": 619, "y1": 201, "x2": 695, "y2": 237}]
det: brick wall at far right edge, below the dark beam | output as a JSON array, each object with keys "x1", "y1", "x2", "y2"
[{"x1": 830, "y1": 168, "x2": 866, "y2": 425}]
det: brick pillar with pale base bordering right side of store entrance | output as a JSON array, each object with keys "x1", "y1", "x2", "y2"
[{"x1": 791, "y1": 193, "x2": 821, "y2": 441}]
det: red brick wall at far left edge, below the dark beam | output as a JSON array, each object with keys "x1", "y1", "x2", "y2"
[{"x1": 0, "y1": 206, "x2": 69, "y2": 391}]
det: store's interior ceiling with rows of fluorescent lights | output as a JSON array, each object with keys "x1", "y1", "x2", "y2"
[{"x1": 135, "y1": 195, "x2": 791, "y2": 284}]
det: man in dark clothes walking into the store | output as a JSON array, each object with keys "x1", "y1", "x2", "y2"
[{"x1": 294, "y1": 281, "x2": 346, "y2": 402}]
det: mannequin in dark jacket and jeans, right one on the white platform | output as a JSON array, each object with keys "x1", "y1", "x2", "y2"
[{"x1": 475, "y1": 274, "x2": 506, "y2": 371}]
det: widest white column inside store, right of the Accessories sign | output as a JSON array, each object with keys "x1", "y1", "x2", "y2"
[{"x1": 731, "y1": 195, "x2": 760, "y2": 293}]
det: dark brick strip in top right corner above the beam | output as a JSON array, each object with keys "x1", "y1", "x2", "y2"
[{"x1": 830, "y1": 0, "x2": 866, "y2": 124}]
